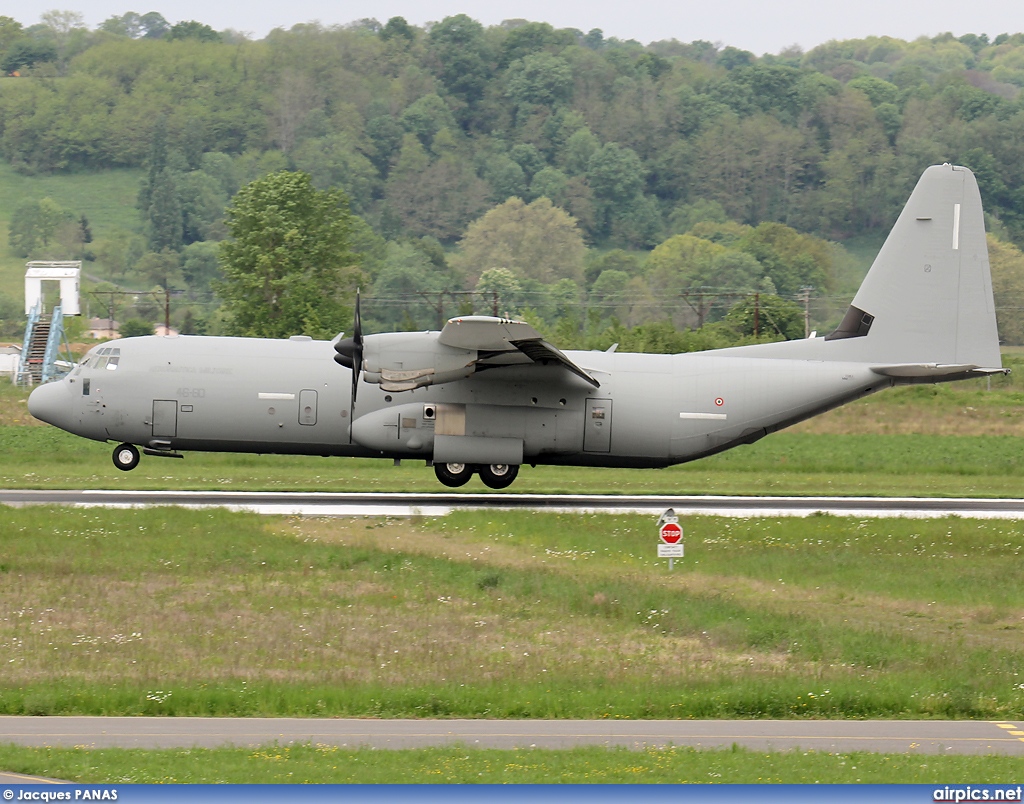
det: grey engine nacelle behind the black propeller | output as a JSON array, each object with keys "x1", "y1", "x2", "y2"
[{"x1": 362, "y1": 332, "x2": 477, "y2": 391}]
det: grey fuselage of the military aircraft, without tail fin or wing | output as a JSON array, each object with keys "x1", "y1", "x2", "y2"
[{"x1": 32, "y1": 336, "x2": 892, "y2": 467}]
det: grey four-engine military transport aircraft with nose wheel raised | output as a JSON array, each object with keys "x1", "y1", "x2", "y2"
[{"x1": 29, "y1": 165, "x2": 1004, "y2": 489}]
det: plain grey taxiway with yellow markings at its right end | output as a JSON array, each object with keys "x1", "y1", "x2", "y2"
[{"x1": 0, "y1": 716, "x2": 1024, "y2": 757}]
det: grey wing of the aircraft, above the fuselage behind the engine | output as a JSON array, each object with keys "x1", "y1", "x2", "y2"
[{"x1": 437, "y1": 315, "x2": 601, "y2": 388}]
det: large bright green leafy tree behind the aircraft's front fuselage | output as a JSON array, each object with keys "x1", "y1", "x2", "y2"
[{"x1": 219, "y1": 171, "x2": 361, "y2": 338}]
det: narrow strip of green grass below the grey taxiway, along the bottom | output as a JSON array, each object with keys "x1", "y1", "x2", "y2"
[{"x1": 0, "y1": 745, "x2": 1020, "y2": 785}]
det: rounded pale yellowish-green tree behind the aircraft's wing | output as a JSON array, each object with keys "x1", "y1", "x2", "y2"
[{"x1": 453, "y1": 198, "x2": 587, "y2": 283}]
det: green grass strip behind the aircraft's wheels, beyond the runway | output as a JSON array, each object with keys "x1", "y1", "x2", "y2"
[{"x1": 0, "y1": 425, "x2": 1024, "y2": 497}]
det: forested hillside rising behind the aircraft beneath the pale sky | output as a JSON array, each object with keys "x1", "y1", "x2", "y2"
[{"x1": 0, "y1": 12, "x2": 1024, "y2": 348}]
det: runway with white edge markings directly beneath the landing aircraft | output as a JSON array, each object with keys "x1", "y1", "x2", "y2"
[{"x1": 0, "y1": 490, "x2": 1024, "y2": 519}]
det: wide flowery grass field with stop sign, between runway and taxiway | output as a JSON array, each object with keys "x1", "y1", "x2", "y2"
[{"x1": 0, "y1": 508, "x2": 1024, "y2": 719}]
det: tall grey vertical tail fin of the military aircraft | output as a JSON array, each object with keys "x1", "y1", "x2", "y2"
[{"x1": 825, "y1": 165, "x2": 1001, "y2": 368}]
